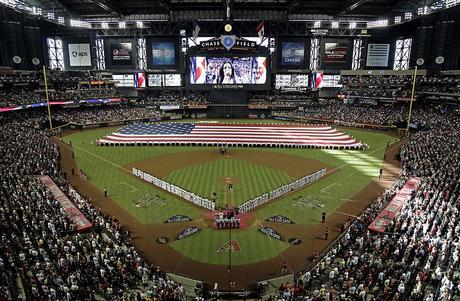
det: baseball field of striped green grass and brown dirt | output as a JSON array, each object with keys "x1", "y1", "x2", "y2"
[{"x1": 60, "y1": 121, "x2": 399, "y2": 287}]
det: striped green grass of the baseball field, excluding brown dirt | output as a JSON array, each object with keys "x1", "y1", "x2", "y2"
[{"x1": 64, "y1": 119, "x2": 394, "y2": 265}]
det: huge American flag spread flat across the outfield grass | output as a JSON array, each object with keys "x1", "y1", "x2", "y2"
[{"x1": 98, "y1": 123, "x2": 363, "y2": 148}]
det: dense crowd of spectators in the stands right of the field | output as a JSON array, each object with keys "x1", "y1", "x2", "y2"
[{"x1": 278, "y1": 104, "x2": 460, "y2": 301}]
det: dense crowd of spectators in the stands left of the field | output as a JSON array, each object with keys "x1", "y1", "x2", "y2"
[{"x1": 0, "y1": 112, "x2": 184, "y2": 300}]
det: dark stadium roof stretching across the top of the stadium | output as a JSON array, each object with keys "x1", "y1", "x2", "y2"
[{"x1": 23, "y1": 0, "x2": 443, "y2": 21}]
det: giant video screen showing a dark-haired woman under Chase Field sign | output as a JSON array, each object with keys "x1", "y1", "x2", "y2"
[{"x1": 189, "y1": 56, "x2": 268, "y2": 86}]
